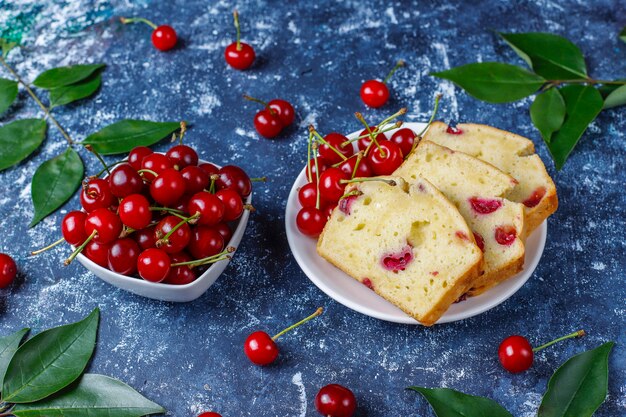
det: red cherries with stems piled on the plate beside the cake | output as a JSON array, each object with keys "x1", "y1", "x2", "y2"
[{"x1": 296, "y1": 109, "x2": 419, "y2": 238}]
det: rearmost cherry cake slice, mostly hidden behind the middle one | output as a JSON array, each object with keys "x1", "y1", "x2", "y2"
[{"x1": 424, "y1": 122, "x2": 559, "y2": 234}]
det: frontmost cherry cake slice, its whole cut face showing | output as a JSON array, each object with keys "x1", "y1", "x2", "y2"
[{"x1": 317, "y1": 177, "x2": 483, "y2": 326}]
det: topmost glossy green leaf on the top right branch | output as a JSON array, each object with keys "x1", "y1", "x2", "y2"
[{"x1": 499, "y1": 32, "x2": 587, "y2": 80}]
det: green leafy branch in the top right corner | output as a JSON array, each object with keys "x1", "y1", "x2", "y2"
[{"x1": 431, "y1": 28, "x2": 626, "y2": 170}]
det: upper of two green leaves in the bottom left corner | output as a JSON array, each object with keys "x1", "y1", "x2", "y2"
[{"x1": 2, "y1": 308, "x2": 100, "y2": 403}]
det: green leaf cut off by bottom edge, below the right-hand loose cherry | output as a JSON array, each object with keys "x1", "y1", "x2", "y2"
[{"x1": 408, "y1": 387, "x2": 513, "y2": 417}]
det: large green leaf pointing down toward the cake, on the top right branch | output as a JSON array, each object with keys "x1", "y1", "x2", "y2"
[{"x1": 548, "y1": 85, "x2": 604, "y2": 170}]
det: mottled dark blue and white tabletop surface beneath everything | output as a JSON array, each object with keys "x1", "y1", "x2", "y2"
[{"x1": 0, "y1": 0, "x2": 626, "y2": 417}]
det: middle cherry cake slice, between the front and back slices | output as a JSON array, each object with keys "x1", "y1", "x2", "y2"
[{"x1": 394, "y1": 140, "x2": 525, "y2": 295}]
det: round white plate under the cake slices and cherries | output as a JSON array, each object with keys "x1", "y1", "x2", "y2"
[{"x1": 285, "y1": 123, "x2": 548, "y2": 324}]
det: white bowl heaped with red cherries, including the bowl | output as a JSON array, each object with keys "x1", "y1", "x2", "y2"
[{"x1": 48, "y1": 143, "x2": 252, "y2": 302}]
